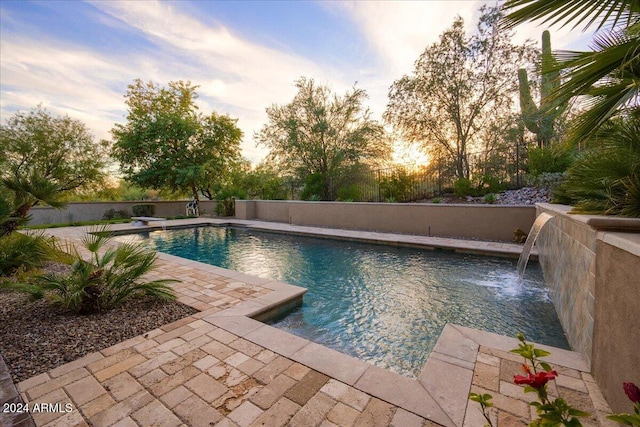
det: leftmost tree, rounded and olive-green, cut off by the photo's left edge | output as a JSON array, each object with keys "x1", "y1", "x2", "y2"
[{"x1": 0, "y1": 106, "x2": 106, "y2": 236}]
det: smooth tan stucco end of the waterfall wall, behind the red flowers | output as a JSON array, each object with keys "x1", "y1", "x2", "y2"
[{"x1": 592, "y1": 239, "x2": 640, "y2": 413}]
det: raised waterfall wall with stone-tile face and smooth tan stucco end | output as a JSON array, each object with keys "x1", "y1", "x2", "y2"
[{"x1": 536, "y1": 204, "x2": 640, "y2": 413}]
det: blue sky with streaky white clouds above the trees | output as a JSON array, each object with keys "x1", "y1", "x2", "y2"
[{"x1": 0, "y1": 0, "x2": 591, "y2": 164}]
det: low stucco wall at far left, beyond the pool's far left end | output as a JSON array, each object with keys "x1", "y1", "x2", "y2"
[{"x1": 29, "y1": 200, "x2": 217, "y2": 225}]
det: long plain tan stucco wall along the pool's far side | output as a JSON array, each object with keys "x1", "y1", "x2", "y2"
[{"x1": 236, "y1": 200, "x2": 535, "y2": 241}]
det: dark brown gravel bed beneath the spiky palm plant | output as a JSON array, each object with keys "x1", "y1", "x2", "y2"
[{"x1": 0, "y1": 292, "x2": 197, "y2": 383}]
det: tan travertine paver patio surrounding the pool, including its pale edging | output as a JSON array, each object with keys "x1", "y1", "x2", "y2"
[{"x1": 6, "y1": 220, "x2": 615, "y2": 427}]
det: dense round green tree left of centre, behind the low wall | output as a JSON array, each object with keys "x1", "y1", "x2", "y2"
[{"x1": 111, "y1": 79, "x2": 242, "y2": 199}]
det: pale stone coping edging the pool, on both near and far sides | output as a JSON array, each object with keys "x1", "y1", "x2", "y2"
[{"x1": 118, "y1": 218, "x2": 576, "y2": 427}]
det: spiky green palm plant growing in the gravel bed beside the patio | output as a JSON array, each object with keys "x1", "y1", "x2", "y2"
[{"x1": 35, "y1": 226, "x2": 177, "y2": 314}]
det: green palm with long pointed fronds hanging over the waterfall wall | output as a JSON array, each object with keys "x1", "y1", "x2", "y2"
[{"x1": 504, "y1": 0, "x2": 640, "y2": 217}]
